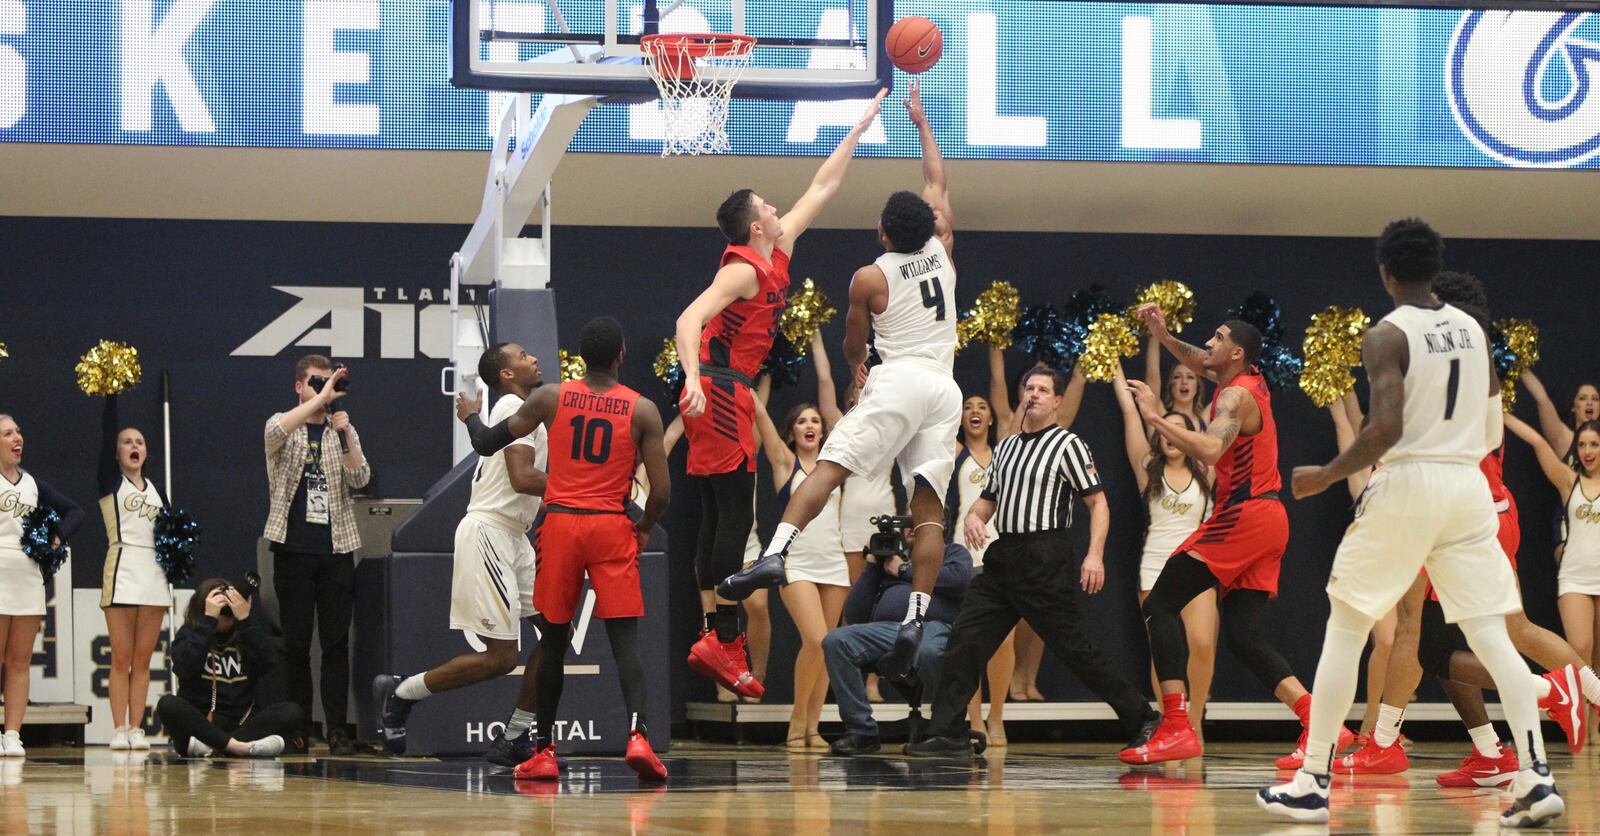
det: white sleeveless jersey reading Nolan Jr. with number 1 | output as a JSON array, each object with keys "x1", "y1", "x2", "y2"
[{"x1": 1382, "y1": 304, "x2": 1499, "y2": 464}]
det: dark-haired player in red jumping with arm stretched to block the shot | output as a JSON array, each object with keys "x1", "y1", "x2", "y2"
[{"x1": 677, "y1": 90, "x2": 888, "y2": 698}]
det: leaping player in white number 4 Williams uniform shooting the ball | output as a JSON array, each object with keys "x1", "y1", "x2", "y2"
[{"x1": 718, "y1": 82, "x2": 962, "y2": 676}]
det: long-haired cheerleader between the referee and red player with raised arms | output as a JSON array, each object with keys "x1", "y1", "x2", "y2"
[{"x1": 1112, "y1": 365, "x2": 1219, "y2": 730}]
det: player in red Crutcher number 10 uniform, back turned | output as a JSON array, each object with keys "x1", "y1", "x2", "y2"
[{"x1": 456, "y1": 317, "x2": 670, "y2": 780}]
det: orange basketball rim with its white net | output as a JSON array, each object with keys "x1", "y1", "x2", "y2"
[{"x1": 638, "y1": 34, "x2": 755, "y2": 157}]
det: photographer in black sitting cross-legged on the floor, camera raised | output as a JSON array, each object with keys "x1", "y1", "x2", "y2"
[{"x1": 155, "y1": 578, "x2": 306, "y2": 758}]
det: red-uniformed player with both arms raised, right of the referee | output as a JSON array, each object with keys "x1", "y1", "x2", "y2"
[{"x1": 1120, "y1": 304, "x2": 1355, "y2": 769}]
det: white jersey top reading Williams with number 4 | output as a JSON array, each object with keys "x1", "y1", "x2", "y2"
[{"x1": 872, "y1": 239, "x2": 957, "y2": 373}]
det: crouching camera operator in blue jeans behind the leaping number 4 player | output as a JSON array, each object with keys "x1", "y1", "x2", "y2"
[{"x1": 822, "y1": 517, "x2": 973, "y2": 754}]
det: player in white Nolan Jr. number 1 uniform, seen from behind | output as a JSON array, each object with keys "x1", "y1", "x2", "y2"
[{"x1": 1256, "y1": 219, "x2": 1565, "y2": 826}]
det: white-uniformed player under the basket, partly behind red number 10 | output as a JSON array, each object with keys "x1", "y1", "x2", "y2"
[{"x1": 373, "y1": 343, "x2": 549, "y2": 766}]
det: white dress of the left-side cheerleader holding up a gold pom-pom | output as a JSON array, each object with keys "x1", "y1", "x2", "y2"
[{"x1": 101, "y1": 474, "x2": 173, "y2": 607}]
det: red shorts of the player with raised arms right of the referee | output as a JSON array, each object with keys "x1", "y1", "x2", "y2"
[{"x1": 1177, "y1": 500, "x2": 1290, "y2": 592}]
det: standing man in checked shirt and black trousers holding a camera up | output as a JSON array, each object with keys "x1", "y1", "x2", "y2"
[{"x1": 264, "y1": 354, "x2": 373, "y2": 756}]
